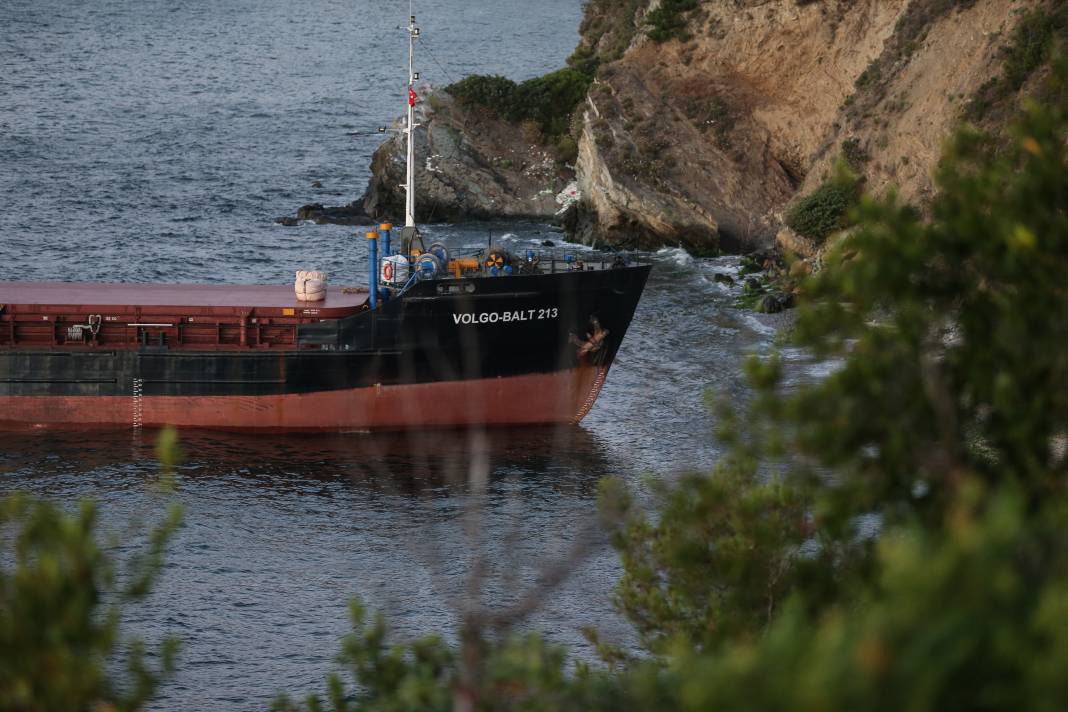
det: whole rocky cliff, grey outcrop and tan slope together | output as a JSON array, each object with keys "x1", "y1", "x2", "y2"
[{"x1": 365, "y1": 0, "x2": 1065, "y2": 251}]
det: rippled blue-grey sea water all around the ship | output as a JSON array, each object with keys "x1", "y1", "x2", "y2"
[{"x1": 0, "y1": 0, "x2": 800, "y2": 710}]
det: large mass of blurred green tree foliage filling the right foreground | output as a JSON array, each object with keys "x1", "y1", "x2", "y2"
[{"x1": 598, "y1": 55, "x2": 1068, "y2": 709}]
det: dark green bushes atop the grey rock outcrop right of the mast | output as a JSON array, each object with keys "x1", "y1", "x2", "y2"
[{"x1": 445, "y1": 68, "x2": 592, "y2": 138}]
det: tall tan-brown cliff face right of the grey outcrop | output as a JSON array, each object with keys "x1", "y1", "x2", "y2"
[{"x1": 577, "y1": 0, "x2": 1038, "y2": 251}]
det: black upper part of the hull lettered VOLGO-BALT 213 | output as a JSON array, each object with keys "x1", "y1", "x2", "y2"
[{"x1": 0, "y1": 266, "x2": 650, "y2": 427}]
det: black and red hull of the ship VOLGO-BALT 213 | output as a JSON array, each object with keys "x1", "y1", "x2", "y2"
[{"x1": 0, "y1": 266, "x2": 648, "y2": 431}]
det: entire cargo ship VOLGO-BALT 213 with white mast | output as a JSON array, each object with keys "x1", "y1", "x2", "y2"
[{"x1": 0, "y1": 16, "x2": 650, "y2": 432}]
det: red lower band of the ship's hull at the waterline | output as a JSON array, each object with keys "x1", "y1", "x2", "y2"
[{"x1": 0, "y1": 366, "x2": 608, "y2": 431}]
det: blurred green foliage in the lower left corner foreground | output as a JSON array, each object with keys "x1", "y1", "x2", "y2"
[{"x1": 0, "y1": 495, "x2": 182, "y2": 712}]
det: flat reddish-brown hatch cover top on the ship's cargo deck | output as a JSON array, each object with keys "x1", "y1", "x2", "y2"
[{"x1": 0, "y1": 282, "x2": 368, "y2": 319}]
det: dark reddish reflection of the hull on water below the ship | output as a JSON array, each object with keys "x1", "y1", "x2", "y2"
[{"x1": 0, "y1": 426, "x2": 609, "y2": 495}]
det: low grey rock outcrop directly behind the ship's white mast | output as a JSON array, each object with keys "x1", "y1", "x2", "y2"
[{"x1": 363, "y1": 88, "x2": 574, "y2": 222}]
